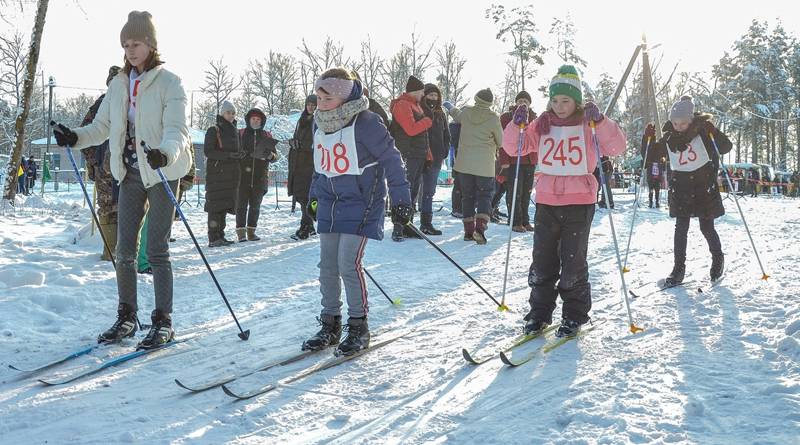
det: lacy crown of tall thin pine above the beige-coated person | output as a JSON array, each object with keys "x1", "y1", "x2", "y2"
[{"x1": 486, "y1": 5, "x2": 547, "y2": 90}]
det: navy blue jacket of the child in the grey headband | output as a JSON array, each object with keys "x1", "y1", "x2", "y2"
[{"x1": 309, "y1": 110, "x2": 411, "y2": 240}]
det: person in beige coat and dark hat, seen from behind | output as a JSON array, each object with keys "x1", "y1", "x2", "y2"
[{"x1": 442, "y1": 88, "x2": 503, "y2": 244}]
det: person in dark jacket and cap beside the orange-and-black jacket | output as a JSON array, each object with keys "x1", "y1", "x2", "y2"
[{"x1": 419, "y1": 83, "x2": 450, "y2": 235}]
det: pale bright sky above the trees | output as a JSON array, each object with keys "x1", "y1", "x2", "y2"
[{"x1": 0, "y1": 0, "x2": 800, "y2": 110}]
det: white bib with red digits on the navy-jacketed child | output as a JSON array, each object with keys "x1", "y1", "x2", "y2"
[{"x1": 314, "y1": 116, "x2": 375, "y2": 178}]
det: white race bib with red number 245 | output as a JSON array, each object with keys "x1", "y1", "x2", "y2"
[{"x1": 539, "y1": 125, "x2": 589, "y2": 176}]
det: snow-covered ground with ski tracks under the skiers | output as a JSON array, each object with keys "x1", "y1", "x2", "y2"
[{"x1": 0, "y1": 178, "x2": 800, "y2": 444}]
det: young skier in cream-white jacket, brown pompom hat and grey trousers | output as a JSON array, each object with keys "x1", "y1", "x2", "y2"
[{"x1": 55, "y1": 11, "x2": 192, "y2": 349}]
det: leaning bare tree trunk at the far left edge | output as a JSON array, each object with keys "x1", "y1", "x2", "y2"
[{"x1": 3, "y1": 0, "x2": 49, "y2": 201}]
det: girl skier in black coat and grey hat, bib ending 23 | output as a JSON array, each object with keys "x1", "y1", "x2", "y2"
[{"x1": 642, "y1": 96, "x2": 733, "y2": 286}]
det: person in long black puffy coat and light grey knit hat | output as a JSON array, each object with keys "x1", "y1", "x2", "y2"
[{"x1": 203, "y1": 100, "x2": 244, "y2": 247}]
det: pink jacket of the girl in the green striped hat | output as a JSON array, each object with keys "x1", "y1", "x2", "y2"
[{"x1": 503, "y1": 112, "x2": 627, "y2": 206}]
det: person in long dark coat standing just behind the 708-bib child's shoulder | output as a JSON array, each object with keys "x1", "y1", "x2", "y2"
[{"x1": 286, "y1": 94, "x2": 317, "y2": 240}]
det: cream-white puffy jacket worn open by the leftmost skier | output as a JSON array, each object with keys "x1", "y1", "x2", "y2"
[{"x1": 72, "y1": 66, "x2": 192, "y2": 188}]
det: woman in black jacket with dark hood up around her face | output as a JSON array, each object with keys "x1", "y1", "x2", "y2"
[{"x1": 236, "y1": 108, "x2": 278, "y2": 242}]
